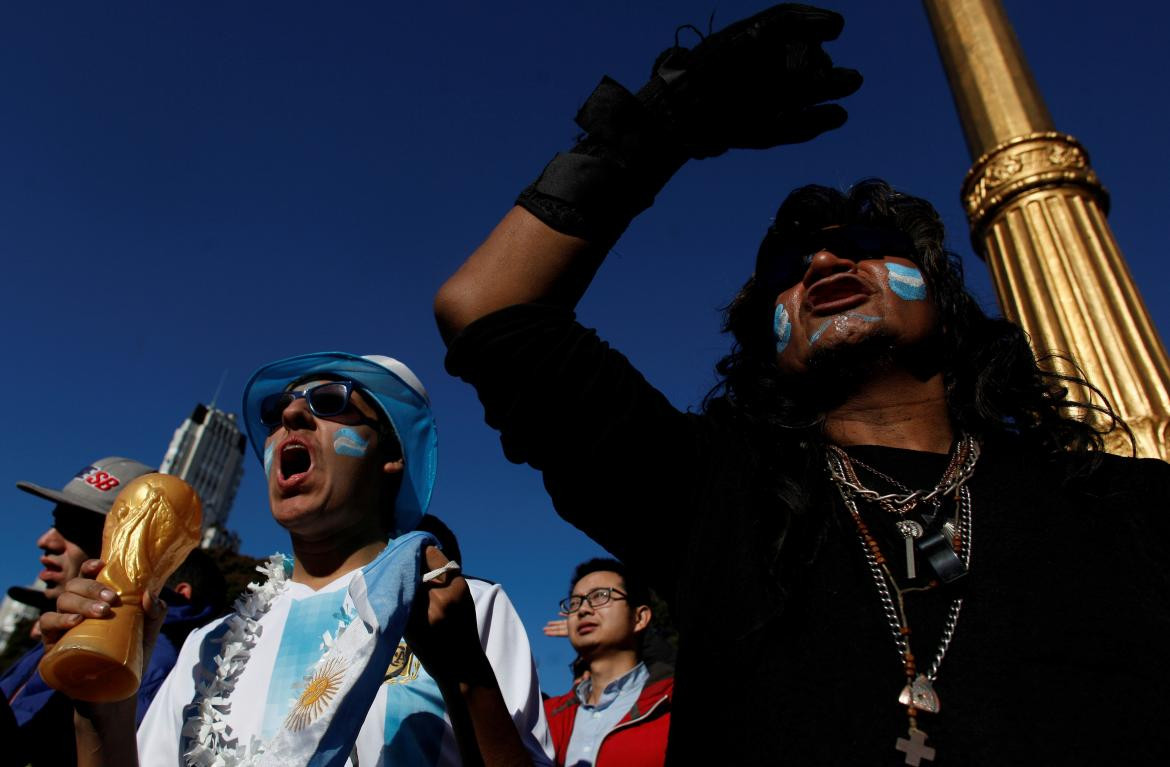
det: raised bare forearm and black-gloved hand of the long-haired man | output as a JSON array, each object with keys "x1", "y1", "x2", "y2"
[{"x1": 435, "y1": 5, "x2": 861, "y2": 341}]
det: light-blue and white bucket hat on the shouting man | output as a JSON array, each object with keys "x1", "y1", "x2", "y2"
[{"x1": 243, "y1": 352, "x2": 439, "y2": 535}]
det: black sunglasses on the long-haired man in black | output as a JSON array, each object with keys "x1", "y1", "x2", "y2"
[{"x1": 756, "y1": 224, "x2": 914, "y2": 293}]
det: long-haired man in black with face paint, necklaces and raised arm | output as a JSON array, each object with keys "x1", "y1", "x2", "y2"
[{"x1": 436, "y1": 6, "x2": 1170, "y2": 766}]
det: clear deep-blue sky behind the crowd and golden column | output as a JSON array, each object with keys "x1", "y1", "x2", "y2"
[{"x1": 0, "y1": 0, "x2": 1170, "y2": 691}]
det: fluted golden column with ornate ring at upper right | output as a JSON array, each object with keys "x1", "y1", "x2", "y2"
[{"x1": 923, "y1": 0, "x2": 1170, "y2": 461}]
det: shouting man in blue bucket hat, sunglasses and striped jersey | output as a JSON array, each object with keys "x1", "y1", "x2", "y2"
[{"x1": 50, "y1": 352, "x2": 551, "y2": 766}]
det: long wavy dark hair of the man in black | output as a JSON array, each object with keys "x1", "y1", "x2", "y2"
[{"x1": 703, "y1": 179, "x2": 1126, "y2": 561}]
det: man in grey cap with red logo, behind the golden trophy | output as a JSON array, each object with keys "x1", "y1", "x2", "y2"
[{"x1": 0, "y1": 456, "x2": 154, "y2": 765}]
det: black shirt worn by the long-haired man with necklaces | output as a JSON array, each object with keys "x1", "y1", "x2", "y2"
[{"x1": 447, "y1": 305, "x2": 1170, "y2": 767}]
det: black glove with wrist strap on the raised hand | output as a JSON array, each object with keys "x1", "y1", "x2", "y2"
[{"x1": 517, "y1": 5, "x2": 861, "y2": 244}]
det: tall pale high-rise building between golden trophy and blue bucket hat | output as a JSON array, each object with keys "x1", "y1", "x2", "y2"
[{"x1": 159, "y1": 403, "x2": 246, "y2": 548}]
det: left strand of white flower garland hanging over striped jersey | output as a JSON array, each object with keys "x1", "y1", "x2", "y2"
[{"x1": 183, "y1": 554, "x2": 288, "y2": 767}]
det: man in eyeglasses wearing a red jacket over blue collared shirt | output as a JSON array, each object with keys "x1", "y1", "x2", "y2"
[{"x1": 544, "y1": 559, "x2": 674, "y2": 767}]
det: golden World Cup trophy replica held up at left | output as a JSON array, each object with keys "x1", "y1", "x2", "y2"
[{"x1": 39, "y1": 474, "x2": 202, "y2": 703}]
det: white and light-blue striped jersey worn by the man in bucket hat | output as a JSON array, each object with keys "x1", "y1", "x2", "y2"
[{"x1": 138, "y1": 571, "x2": 553, "y2": 767}]
